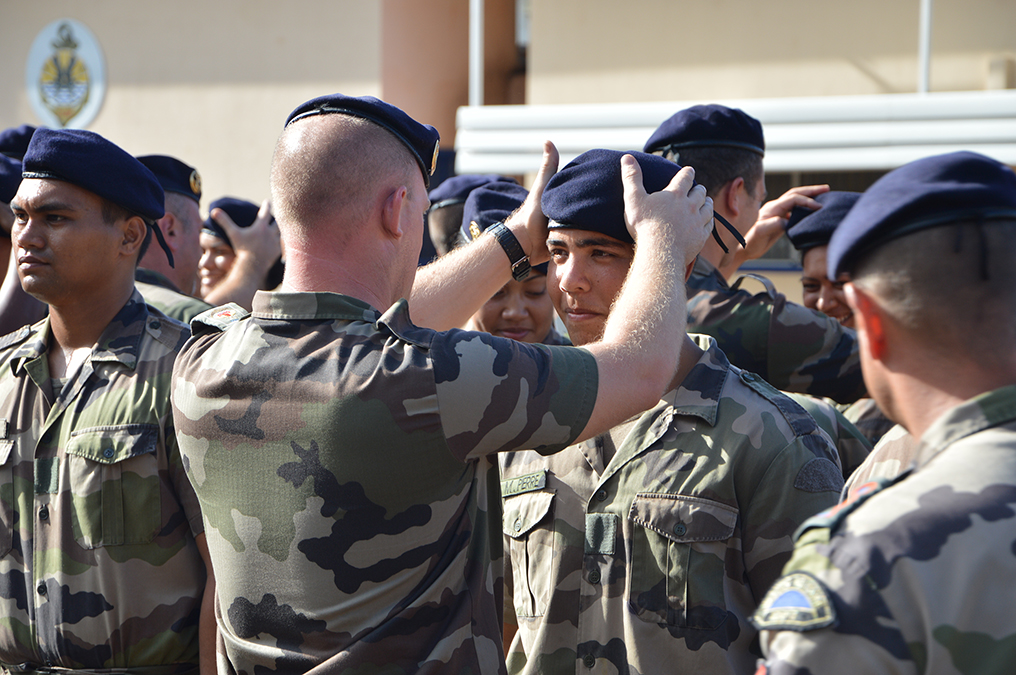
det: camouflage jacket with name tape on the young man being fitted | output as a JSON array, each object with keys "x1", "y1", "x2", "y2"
[{"x1": 500, "y1": 335, "x2": 843, "y2": 675}]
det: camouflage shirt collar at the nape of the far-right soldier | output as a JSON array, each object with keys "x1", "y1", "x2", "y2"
[{"x1": 916, "y1": 385, "x2": 1016, "y2": 467}]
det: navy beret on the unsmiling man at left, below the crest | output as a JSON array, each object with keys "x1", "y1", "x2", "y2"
[{"x1": 21, "y1": 127, "x2": 166, "y2": 221}]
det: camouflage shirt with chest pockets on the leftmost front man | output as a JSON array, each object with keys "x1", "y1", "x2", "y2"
[{"x1": 0, "y1": 291, "x2": 205, "y2": 674}]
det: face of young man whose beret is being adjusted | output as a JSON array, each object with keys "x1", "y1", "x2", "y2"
[{"x1": 547, "y1": 230, "x2": 635, "y2": 345}]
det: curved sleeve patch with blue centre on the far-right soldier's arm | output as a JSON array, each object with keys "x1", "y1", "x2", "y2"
[{"x1": 750, "y1": 571, "x2": 837, "y2": 632}]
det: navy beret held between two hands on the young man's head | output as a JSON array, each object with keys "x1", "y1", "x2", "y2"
[{"x1": 542, "y1": 149, "x2": 681, "y2": 244}]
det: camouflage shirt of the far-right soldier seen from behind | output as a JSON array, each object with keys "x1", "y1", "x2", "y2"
[{"x1": 753, "y1": 386, "x2": 1016, "y2": 675}]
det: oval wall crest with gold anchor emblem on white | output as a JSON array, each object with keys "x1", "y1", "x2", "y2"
[{"x1": 24, "y1": 18, "x2": 106, "y2": 129}]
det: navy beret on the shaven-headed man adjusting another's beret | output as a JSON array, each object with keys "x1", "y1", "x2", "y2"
[{"x1": 285, "y1": 94, "x2": 441, "y2": 187}]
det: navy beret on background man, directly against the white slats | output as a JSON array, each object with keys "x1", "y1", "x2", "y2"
[{"x1": 643, "y1": 104, "x2": 765, "y2": 156}]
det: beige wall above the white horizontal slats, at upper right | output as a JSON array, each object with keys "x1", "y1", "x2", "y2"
[{"x1": 526, "y1": 0, "x2": 1016, "y2": 104}]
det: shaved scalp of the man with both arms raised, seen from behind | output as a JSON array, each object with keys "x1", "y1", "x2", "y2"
[{"x1": 271, "y1": 114, "x2": 424, "y2": 244}]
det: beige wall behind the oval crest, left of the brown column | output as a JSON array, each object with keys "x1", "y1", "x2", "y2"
[{"x1": 0, "y1": 0, "x2": 381, "y2": 210}]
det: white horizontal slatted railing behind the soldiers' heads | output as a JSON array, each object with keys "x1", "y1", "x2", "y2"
[{"x1": 455, "y1": 90, "x2": 1016, "y2": 174}]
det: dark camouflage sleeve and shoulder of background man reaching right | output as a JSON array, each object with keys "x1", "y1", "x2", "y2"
[{"x1": 688, "y1": 257, "x2": 865, "y2": 404}]
